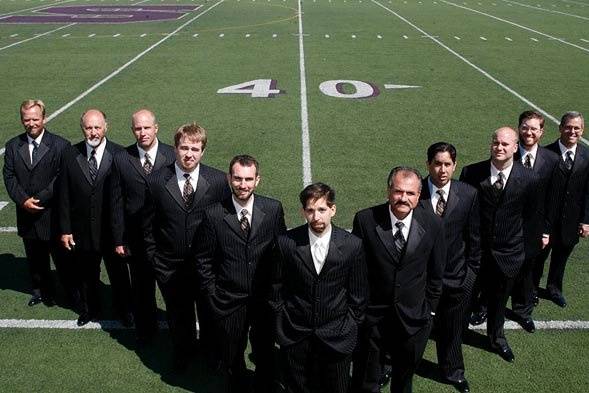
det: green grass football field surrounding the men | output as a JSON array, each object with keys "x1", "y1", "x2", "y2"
[{"x1": 0, "y1": 0, "x2": 589, "y2": 392}]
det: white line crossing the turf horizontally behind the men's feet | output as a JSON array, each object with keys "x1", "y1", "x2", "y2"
[{"x1": 0, "y1": 319, "x2": 589, "y2": 330}]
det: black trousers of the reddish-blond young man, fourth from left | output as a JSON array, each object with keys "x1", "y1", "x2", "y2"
[{"x1": 158, "y1": 269, "x2": 196, "y2": 361}]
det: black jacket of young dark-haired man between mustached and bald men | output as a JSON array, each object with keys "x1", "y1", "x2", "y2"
[{"x1": 420, "y1": 178, "x2": 481, "y2": 288}]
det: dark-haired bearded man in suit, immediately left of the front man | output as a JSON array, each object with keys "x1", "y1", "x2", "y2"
[{"x1": 192, "y1": 155, "x2": 286, "y2": 393}]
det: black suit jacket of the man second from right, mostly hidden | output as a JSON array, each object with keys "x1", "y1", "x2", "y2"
[{"x1": 514, "y1": 146, "x2": 558, "y2": 259}]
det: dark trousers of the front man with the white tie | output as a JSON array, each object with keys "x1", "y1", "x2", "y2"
[{"x1": 280, "y1": 337, "x2": 352, "y2": 393}]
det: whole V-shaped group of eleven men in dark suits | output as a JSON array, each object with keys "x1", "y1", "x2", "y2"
[{"x1": 4, "y1": 100, "x2": 589, "y2": 393}]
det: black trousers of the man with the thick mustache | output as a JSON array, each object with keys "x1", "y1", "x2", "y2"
[{"x1": 352, "y1": 315, "x2": 432, "y2": 393}]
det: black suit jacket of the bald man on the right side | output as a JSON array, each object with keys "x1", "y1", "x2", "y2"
[{"x1": 460, "y1": 160, "x2": 544, "y2": 277}]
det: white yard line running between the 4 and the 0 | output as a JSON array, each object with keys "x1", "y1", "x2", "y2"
[{"x1": 298, "y1": 0, "x2": 313, "y2": 187}]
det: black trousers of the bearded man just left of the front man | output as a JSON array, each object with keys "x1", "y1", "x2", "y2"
[{"x1": 214, "y1": 299, "x2": 278, "y2": 393}]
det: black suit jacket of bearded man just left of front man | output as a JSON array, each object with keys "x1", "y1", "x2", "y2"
[{"x1": 192, "y1": 195, "x2": 286, "y2": 318}]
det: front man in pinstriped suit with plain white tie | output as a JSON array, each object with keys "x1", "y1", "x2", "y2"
[{"x1": 271, "y1": 183, "x2": 368, "y2": 393}]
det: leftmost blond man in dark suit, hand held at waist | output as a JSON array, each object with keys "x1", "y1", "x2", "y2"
[{"x1": 2, "y1": 100, "x2": 70, "y2": 307}]
